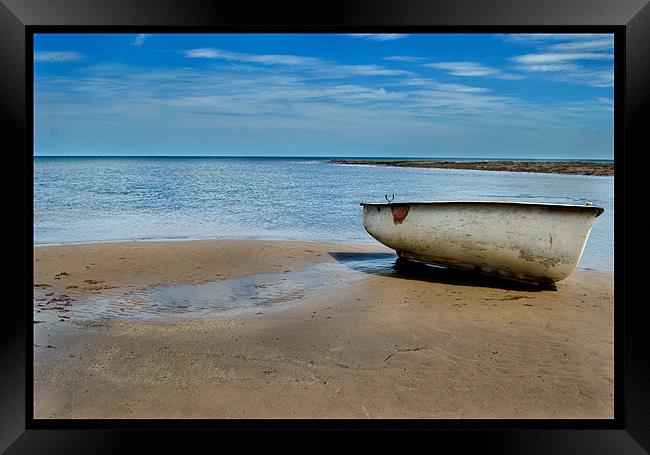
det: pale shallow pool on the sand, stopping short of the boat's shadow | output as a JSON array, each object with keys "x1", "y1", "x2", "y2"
[{"x1": 34, "y1": 262, "x2": 363, "y2": 320}]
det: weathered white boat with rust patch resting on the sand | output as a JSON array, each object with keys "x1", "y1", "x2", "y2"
[{"x1": 361, "y1": 200, "x2": 604, "y2": 283}]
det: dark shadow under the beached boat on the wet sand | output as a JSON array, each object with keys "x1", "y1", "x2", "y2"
[{"x1": 328, "y1": 252, "x2": 557, "y2": 292}]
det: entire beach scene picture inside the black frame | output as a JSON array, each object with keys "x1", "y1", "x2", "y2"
[{"x1": 30, "y1": 33, "x2": 616, "y2": 420}]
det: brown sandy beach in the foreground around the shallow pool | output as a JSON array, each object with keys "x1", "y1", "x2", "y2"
[{"x1": 34, "y1": 240, "x2": 613, "y2": 419}]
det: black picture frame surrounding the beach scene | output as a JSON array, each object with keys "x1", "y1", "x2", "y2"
[{"x1": 0, "y1": 0, "x2": 650, "y2": 453}]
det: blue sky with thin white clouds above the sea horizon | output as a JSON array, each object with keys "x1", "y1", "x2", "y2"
[{"x1": 34, "y1": 34, "x2": 614, "y2": 159}]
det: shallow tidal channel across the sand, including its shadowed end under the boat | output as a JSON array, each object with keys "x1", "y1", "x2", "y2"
[{"x1": 34, "y1": 252, "x2": 554, "y2": 320}]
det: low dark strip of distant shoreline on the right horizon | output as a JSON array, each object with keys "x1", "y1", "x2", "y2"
[{"x1": 329, "y1": 159, "x2": 614, "y2": 176}]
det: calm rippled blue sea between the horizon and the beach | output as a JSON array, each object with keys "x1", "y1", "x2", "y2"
[{"x1": 34, "y1": 157, "x2": 614, "y2": 271}]
